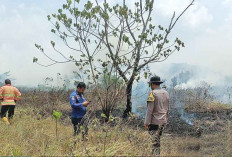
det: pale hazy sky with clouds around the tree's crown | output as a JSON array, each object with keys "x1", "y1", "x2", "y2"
[{"x1": 0, "y1": 0, "x2": 232, "y2": 86}]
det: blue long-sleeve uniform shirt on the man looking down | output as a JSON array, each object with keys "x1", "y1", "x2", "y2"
[{"x1": 69, "y1": 90, "x2": 86, "y2": 118}]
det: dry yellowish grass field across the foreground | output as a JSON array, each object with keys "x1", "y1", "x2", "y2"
[{"x1": 0, "y1": 106, "x2": 232, "y2": 156}]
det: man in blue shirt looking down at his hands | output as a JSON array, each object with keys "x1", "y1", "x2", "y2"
[{"x1": 69, "y1": 82, "x2": 89, "y2": 136}]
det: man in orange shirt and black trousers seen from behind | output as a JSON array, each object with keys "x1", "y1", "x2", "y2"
[{"x1": 0, "y1": 79, "x2": 21, "y2": 124}]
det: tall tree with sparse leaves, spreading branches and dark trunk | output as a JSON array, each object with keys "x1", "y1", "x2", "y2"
[{"x1": 34, "y1": 0, "x2": 194, "y2": 117}]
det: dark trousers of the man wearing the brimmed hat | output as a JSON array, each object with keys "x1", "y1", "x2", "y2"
[{"x1": 148, "y1": 124, "x2": 164, "y2": 155}]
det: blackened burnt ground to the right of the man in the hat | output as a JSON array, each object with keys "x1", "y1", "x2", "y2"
[{"x1": 166, "y1": 108, "x2": 232, "y2": 136}]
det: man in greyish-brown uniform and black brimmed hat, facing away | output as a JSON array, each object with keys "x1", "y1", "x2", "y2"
[{"x1": 144, "y1": 76, "x2": 169, "y2": 155}]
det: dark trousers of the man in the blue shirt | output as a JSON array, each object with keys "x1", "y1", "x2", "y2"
[{"x1": 71, "y1": 118, "x2": 88, "y2": 137}]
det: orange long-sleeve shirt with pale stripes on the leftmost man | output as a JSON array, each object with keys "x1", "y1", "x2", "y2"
[{"x1": 0, "y1": 84, "x2": 21, "y2": 105}]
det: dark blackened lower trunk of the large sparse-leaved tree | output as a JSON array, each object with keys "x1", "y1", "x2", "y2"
[{"x1": 123, "y1": 79, "x2": 134, "y2": 118}]
